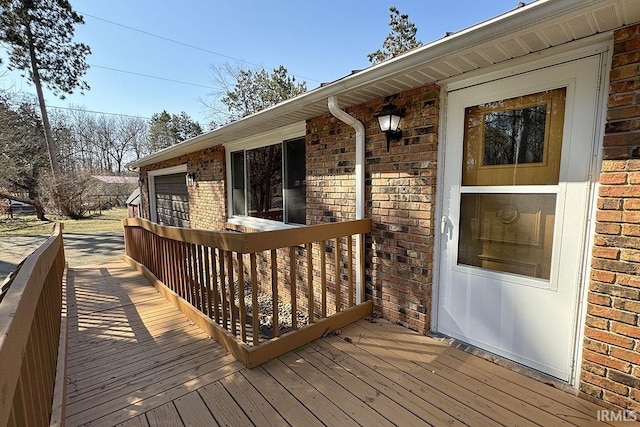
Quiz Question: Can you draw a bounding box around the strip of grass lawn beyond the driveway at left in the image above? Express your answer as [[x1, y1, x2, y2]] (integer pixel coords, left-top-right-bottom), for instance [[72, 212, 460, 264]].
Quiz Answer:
[[0, 208, 127, 237]]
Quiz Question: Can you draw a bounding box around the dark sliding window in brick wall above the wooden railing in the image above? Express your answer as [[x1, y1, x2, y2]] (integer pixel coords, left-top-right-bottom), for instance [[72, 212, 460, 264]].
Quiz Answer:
[[230, 138, 307, 224]]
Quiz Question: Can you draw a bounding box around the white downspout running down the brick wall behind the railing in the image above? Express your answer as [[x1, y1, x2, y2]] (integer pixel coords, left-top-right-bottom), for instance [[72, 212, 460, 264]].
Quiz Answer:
[[328, 95, 364, 304]]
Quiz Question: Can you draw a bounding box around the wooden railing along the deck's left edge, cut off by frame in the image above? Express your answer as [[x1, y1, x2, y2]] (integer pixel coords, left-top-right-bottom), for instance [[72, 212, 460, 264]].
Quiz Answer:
[[0, 224, 66, 426]]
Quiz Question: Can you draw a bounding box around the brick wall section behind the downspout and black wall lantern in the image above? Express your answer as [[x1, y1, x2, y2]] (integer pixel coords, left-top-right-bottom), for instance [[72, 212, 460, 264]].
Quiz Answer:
[[307, 85, 440, 332]]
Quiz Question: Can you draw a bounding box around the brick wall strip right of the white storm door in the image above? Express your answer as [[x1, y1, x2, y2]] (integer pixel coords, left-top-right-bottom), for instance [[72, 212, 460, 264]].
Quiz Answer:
[[580, 25, 640, 411]]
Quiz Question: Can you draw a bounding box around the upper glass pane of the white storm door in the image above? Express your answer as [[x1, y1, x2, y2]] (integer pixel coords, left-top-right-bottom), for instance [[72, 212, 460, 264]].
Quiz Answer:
[[462, 88, 566, 186]]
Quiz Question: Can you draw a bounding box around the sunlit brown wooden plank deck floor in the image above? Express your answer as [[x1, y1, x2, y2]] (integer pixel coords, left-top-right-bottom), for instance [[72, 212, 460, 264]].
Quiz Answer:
[[66, 263, 616, 427]]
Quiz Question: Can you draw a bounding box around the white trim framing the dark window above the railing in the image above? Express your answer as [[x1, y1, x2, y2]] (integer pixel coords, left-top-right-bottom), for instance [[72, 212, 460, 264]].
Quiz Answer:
[[224, 122, 307, 231]]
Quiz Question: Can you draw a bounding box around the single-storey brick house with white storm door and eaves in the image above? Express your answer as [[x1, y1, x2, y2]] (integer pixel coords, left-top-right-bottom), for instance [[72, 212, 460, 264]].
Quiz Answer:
[[132, 0, 640, 410]]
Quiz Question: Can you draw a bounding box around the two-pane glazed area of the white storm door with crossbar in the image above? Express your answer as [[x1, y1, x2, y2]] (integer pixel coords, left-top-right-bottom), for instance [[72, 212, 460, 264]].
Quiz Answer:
[[458, 88, 566, 280]]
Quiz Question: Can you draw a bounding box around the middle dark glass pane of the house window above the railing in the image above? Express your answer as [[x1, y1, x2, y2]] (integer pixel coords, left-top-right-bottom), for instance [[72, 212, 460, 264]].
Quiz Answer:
[[246, 144, 283, 221]]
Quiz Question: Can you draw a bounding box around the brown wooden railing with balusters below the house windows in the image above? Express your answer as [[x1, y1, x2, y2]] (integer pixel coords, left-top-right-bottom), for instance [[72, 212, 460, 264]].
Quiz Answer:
[[123, 218, 372, 367]]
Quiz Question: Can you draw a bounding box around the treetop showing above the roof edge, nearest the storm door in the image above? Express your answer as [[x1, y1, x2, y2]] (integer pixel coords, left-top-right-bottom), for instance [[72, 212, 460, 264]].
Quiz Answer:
[[367, 6, 422, 64]]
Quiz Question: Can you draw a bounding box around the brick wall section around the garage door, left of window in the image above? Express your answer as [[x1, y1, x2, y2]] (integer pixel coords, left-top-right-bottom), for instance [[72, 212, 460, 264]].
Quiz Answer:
[[140, 147, 226, 230]]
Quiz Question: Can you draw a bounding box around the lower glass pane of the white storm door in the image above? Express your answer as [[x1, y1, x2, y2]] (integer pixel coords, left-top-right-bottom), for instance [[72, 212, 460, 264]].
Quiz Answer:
[[458, 193, 556, 280]]
